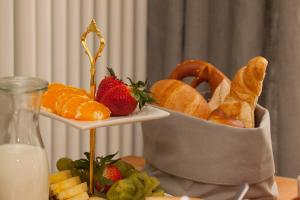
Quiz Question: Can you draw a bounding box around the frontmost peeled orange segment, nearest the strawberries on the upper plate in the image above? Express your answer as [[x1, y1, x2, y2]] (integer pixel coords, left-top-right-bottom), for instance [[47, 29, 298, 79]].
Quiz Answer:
[[75, 101, 110, 121]]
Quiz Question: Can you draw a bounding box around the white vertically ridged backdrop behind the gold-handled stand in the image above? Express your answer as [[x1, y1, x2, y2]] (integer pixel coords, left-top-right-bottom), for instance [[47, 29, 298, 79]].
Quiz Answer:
[[0, 0, 147, 170]]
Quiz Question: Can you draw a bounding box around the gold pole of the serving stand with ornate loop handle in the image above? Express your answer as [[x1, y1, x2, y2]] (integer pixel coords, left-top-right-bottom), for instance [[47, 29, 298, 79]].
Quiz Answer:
[[81, 19, 105, 194]]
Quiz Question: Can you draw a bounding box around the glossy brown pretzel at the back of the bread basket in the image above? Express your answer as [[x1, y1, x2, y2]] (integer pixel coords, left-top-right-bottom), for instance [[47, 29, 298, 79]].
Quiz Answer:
[[169, 60, 230, 93]]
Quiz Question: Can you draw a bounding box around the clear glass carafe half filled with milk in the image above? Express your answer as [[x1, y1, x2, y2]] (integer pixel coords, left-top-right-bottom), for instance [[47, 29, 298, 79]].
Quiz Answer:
[[0, 77, 49, 200]]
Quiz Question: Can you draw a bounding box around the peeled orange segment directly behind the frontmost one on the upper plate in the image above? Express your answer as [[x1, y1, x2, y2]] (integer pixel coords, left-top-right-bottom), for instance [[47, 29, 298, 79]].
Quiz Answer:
[[61, 95, 90, 119]]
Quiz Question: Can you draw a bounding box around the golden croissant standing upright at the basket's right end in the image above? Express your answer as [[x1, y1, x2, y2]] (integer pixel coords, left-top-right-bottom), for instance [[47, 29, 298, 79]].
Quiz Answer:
[[209, 56, 268, 128]]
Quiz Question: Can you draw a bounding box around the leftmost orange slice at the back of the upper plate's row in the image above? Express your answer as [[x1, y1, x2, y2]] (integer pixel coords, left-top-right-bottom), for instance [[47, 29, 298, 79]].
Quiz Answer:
[[41, 87, 87, 112]]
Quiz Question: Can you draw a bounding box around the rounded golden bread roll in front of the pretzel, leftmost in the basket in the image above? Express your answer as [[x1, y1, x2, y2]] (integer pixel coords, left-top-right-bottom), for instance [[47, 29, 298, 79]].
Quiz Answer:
[[150, 79, 211, 119]]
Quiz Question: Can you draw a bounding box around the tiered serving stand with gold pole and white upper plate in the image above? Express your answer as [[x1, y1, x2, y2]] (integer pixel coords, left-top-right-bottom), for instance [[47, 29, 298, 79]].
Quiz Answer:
[[41, 19, 169, 194]]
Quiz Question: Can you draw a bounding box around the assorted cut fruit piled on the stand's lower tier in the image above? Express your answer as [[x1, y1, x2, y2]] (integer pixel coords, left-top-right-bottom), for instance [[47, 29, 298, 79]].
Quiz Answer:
[[49, 152, 165, 200]]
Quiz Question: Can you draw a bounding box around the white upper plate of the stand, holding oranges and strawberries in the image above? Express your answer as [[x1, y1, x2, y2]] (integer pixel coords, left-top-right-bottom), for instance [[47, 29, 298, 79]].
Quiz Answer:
[[41, 105, 170, 130]]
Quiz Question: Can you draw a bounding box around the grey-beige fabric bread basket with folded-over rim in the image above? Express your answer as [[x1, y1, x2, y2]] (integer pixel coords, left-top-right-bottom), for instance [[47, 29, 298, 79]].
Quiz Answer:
[[142, 106, 278, 200]]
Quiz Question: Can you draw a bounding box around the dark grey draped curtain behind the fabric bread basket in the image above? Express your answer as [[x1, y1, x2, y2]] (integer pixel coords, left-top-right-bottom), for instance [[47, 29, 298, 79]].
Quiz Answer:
[[147, 0, 300, 177]]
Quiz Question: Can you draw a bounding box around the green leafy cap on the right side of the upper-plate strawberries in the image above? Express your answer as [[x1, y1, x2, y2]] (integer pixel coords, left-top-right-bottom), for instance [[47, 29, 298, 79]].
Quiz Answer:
[[127, 77, 154, 109]]
